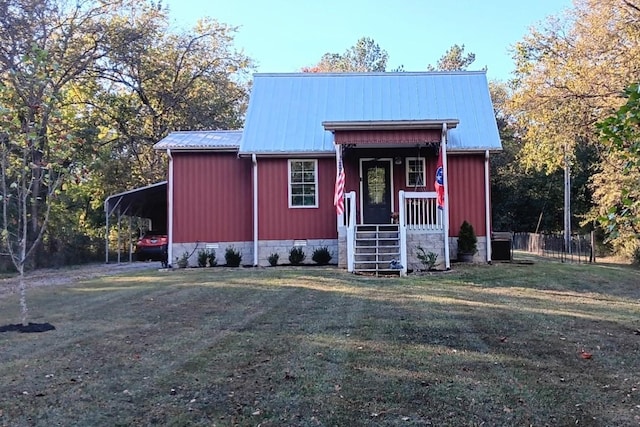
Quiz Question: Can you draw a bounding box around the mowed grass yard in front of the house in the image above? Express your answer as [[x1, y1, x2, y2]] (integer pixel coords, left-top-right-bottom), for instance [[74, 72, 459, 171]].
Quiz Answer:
[[0, 259, 640, 427]]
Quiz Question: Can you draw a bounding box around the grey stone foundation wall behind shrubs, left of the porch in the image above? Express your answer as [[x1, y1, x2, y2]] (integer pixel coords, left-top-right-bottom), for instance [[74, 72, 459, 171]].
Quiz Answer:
[[169, 239, 346, 267]]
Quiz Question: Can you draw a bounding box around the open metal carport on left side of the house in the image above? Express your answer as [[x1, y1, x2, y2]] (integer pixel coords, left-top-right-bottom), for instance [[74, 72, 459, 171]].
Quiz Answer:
[[104, 181, 167, 264]]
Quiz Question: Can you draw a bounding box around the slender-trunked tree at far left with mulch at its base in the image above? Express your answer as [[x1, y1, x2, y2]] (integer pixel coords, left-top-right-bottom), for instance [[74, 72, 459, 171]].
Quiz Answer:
[[0, 0, 129, 324]]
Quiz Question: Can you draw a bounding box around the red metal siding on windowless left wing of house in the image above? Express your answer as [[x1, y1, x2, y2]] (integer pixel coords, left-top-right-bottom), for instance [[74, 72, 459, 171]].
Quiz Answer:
[[173, 152, 253, 243]]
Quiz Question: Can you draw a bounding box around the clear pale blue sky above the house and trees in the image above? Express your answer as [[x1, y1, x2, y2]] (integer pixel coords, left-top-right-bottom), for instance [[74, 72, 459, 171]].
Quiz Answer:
[[162, 0, 572, 81]]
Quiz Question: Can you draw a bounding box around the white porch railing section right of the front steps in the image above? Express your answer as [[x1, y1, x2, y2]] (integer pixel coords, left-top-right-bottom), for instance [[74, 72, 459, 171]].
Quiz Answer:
[[398, 191, 444, 232]]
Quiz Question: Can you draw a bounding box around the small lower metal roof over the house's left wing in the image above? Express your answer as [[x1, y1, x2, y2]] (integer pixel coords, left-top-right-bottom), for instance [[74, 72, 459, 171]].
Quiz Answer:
[[153, 130, 242, 151]]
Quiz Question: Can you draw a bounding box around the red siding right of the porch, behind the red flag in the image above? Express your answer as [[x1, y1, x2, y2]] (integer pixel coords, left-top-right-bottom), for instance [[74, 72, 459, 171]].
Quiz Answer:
[[447, 153, 486, 236]]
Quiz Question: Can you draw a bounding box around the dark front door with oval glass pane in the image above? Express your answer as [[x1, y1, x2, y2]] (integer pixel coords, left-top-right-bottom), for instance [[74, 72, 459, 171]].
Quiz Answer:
[[362, 160, 392, 224]]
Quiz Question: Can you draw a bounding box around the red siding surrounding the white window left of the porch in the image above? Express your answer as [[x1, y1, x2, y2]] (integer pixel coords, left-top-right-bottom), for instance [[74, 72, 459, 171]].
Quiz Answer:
[[258, 157, 338, 240]]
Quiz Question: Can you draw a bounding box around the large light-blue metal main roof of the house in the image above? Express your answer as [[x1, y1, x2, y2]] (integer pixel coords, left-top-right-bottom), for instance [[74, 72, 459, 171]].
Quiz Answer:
[[240, 71, 502, 154]]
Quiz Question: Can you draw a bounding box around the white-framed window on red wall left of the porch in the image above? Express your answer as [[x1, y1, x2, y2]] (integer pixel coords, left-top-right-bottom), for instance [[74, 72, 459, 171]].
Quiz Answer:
[[289, 159, 318, 208]]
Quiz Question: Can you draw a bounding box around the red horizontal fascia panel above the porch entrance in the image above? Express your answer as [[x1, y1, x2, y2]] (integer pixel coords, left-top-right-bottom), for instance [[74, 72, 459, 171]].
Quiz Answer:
[[334, 129, 442, 144]]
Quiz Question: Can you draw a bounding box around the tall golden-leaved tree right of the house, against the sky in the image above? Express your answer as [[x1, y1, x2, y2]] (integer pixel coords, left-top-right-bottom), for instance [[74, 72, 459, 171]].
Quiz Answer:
[[507, 0, 640, 251]]
